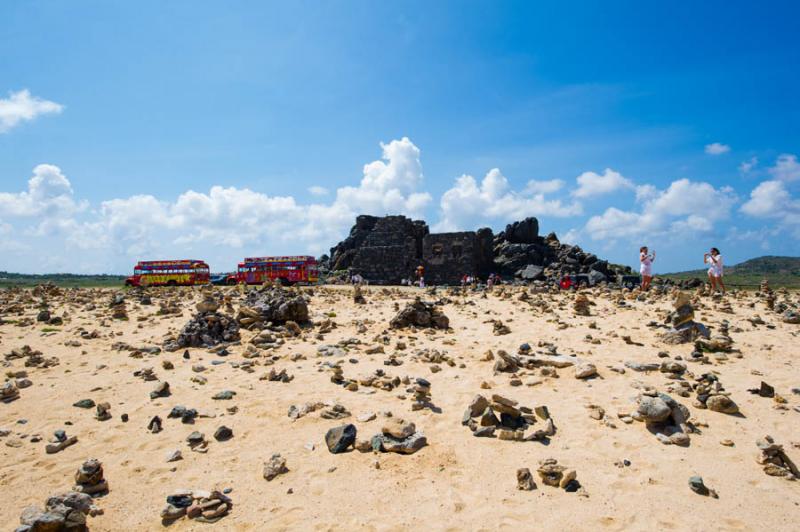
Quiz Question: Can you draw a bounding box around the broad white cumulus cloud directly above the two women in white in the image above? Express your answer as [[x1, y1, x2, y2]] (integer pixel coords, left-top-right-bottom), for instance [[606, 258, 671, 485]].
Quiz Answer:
[[584, 179, 736, 240]]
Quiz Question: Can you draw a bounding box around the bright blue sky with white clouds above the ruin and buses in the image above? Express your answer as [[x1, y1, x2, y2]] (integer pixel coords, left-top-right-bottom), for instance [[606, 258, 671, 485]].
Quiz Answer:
[[0, 1, 800, 272]]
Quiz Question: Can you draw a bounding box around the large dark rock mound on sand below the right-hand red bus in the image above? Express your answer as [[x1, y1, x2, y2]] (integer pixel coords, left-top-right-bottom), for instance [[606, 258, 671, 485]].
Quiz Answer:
[[236, 287, 308, 329]]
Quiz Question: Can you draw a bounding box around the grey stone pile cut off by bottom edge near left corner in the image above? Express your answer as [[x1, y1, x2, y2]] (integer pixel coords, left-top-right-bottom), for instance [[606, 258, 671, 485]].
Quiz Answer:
[[15, 491, 96, 532]]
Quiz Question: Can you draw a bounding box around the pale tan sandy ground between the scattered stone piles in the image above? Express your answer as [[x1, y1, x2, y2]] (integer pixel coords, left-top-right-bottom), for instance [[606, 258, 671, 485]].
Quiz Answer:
[[0, 287, 800, 530]]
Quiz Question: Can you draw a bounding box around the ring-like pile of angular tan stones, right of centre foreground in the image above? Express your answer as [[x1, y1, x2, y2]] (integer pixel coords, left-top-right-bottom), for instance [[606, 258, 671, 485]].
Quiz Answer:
[[461, 394, 556, 442]]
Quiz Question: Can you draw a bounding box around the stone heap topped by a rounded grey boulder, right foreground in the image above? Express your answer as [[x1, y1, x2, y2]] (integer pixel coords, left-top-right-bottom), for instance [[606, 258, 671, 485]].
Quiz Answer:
[[630, 390, 691, 447]]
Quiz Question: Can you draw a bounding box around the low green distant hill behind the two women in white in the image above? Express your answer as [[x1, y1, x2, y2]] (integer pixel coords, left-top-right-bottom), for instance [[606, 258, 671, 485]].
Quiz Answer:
[[658, 255, 800, 288]]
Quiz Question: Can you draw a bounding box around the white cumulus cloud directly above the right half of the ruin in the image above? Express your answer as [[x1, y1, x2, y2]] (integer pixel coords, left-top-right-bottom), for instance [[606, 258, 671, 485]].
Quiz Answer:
[[434, 168, 582, 231]]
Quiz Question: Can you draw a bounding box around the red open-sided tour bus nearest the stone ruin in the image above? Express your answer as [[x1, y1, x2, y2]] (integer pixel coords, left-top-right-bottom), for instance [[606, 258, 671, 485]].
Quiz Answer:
[[227, 255, 319, 285]]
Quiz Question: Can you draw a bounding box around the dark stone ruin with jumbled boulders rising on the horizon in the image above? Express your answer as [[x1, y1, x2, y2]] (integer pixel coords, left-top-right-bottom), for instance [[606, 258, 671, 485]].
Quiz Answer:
[[321, 215, 631, 285]]
